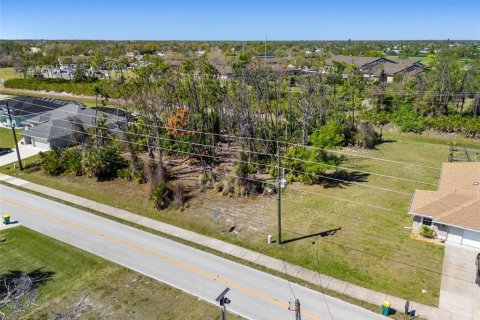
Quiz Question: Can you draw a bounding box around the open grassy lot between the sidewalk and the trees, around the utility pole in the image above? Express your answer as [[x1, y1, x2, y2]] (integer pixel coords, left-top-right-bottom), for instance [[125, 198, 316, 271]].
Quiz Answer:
[[0, 131, 480, 305]]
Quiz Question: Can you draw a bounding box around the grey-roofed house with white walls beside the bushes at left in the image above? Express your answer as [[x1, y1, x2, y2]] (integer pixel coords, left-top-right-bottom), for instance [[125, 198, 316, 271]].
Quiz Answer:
[[22, 103, 126, 150]]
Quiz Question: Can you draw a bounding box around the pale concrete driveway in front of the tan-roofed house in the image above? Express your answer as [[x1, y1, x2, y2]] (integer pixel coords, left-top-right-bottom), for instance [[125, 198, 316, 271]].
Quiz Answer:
[[439, 243, 480, 320]]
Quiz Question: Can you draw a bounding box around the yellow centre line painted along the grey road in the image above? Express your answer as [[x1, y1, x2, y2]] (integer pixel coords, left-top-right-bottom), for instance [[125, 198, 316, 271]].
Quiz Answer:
[[0, 197, 323, 320]]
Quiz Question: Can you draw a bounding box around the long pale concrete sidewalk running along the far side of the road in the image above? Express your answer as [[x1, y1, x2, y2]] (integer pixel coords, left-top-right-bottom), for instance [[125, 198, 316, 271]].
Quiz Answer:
[[0, 174, 454, 320]]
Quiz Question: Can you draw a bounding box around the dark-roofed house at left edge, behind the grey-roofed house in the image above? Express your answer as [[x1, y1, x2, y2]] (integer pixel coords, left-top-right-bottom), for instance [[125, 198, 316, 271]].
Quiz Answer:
[[0, 97, 75, 128]]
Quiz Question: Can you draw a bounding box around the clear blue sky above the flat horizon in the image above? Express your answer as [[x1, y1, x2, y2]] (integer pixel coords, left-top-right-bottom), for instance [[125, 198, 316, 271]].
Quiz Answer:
[[0, 0, 480, 40]]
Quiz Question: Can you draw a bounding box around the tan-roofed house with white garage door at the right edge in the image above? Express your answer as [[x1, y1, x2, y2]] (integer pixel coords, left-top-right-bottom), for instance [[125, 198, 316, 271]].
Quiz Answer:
[[409, 162, 480, 248]]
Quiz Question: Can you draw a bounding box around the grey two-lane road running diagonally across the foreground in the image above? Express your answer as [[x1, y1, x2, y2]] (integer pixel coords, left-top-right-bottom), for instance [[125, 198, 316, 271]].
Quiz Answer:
[[0, 185, 386, 320]]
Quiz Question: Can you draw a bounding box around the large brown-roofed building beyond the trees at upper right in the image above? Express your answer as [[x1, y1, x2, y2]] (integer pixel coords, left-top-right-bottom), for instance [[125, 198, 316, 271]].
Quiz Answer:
[[324, 55, 426, 82]]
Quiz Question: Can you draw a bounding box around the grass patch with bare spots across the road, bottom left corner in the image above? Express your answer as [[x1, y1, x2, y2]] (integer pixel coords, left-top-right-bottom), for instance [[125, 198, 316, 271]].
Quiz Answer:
[[0, 227, 239, 319]]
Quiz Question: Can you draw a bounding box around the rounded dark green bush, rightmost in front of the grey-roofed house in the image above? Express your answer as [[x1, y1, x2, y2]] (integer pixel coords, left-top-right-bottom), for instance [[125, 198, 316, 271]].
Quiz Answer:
[[82, 147, 126, 180]]
